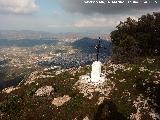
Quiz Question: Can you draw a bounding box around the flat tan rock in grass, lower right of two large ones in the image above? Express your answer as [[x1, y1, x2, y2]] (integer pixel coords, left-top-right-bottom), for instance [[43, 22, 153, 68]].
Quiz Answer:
[[52, 95, 71, 107]]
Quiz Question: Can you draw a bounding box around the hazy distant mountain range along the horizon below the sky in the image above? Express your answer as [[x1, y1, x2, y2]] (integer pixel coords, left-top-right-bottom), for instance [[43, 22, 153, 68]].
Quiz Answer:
[[0, 30, 110, 41]]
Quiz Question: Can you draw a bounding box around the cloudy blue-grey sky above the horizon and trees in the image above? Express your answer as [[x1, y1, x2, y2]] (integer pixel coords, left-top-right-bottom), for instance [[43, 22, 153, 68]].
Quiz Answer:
[[0, 0, 160, 33]]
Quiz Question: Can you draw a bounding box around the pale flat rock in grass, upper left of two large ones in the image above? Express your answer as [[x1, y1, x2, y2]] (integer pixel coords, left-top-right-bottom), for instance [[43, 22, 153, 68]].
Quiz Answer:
[[35, 86, 54, 96]]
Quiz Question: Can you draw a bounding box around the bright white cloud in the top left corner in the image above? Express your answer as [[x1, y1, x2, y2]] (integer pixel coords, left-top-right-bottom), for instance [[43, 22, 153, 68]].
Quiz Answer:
[[0, 0, 38, 14]]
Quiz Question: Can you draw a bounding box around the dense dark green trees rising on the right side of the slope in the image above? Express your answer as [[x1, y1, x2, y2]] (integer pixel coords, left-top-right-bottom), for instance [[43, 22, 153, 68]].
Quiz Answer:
[[111, 12, 160, 62]]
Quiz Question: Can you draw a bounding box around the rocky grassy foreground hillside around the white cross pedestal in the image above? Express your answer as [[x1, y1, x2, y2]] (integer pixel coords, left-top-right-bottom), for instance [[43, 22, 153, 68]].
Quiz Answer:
[[0, 57, 160, 120]]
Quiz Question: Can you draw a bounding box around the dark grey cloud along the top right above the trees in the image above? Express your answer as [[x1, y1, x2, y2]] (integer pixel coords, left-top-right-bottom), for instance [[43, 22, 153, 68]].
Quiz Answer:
[[59, 0, 160, 14]]
